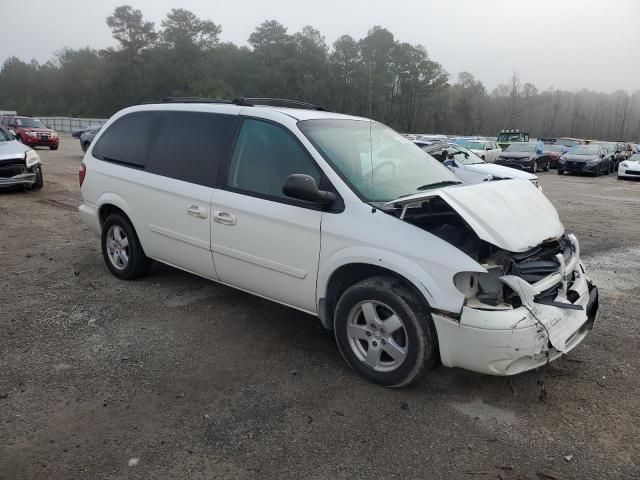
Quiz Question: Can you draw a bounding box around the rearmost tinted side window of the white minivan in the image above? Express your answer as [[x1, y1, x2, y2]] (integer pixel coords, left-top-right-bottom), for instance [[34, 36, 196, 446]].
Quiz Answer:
[[93, 111, 160, 167]]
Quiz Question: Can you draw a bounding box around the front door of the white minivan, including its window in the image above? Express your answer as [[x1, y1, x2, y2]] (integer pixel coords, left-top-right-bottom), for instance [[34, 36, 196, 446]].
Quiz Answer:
[[211, 118, 322, 313]]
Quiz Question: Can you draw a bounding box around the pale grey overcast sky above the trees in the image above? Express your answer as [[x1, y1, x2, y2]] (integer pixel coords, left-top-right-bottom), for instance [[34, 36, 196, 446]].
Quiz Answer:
[[0, 0, 640, 92]]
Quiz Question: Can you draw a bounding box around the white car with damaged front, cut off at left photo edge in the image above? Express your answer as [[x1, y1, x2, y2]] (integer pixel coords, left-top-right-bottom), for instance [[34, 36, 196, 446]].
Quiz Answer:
[[0, 126, 43, 190]]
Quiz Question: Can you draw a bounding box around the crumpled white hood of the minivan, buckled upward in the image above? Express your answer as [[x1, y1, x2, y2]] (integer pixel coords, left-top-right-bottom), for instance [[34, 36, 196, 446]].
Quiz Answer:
[[387, 179, 564, 252]]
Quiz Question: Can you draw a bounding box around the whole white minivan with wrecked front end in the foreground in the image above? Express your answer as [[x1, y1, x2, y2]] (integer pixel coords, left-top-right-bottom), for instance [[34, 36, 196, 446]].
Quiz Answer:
[[79, 99, 598, 387]]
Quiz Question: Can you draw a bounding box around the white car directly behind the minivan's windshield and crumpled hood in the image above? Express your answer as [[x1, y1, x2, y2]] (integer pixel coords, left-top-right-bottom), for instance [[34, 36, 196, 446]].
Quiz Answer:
[[418, 143, 538, 186]]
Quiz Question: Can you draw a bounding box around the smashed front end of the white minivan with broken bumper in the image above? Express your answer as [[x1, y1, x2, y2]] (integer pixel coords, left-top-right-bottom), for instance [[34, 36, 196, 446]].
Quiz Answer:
[[389, 182, 598, 375]]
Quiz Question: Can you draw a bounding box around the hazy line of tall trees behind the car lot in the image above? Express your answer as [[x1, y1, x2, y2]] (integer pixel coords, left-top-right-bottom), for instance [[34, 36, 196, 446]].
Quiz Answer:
[[0, 5, 640, 140]]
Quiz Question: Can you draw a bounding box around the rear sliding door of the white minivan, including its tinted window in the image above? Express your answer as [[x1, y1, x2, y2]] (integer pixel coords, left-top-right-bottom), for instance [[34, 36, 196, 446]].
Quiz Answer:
[[140, 111, 238, 280]]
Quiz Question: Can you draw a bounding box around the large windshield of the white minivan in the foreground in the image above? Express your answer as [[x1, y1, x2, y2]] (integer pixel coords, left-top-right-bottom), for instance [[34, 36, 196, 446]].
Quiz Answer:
[[298, 119, 461, 202]]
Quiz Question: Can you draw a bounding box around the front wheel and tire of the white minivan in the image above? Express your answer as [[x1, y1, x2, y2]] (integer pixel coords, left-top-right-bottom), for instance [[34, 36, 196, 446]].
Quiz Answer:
[[334, 276, 439, 387]]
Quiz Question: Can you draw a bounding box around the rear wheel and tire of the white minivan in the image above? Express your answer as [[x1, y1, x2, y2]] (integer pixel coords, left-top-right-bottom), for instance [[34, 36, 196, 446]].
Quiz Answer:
[[100, 213, 151, 280]]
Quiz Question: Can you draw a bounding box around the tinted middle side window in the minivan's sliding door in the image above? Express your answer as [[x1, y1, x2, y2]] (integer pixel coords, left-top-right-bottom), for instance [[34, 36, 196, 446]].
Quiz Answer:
[[146, 111, 239, 187]]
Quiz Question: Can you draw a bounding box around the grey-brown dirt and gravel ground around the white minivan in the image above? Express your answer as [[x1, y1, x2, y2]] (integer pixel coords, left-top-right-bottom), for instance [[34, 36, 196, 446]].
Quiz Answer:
[[0, 138, 640, 480]]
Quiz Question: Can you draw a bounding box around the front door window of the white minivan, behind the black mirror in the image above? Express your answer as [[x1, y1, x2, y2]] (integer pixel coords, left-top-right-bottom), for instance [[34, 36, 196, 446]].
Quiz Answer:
[[227, 119, 321, 199]]
